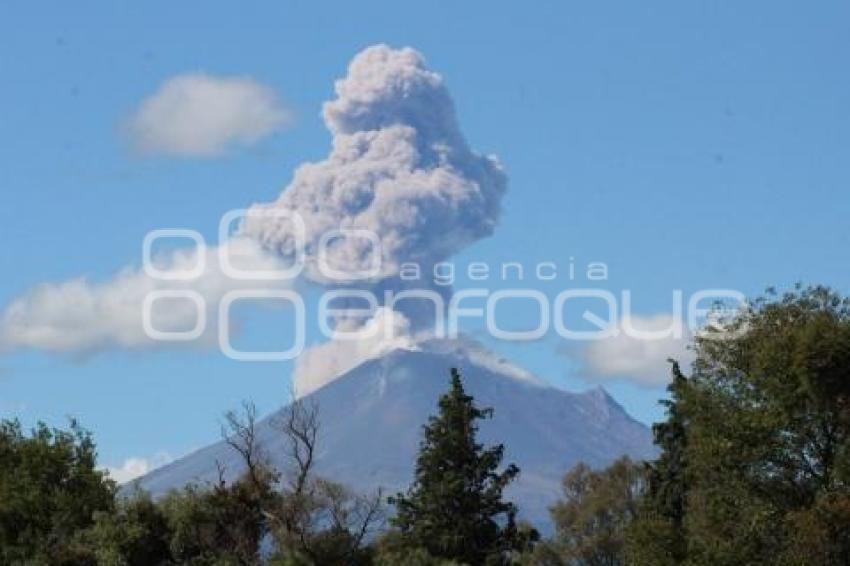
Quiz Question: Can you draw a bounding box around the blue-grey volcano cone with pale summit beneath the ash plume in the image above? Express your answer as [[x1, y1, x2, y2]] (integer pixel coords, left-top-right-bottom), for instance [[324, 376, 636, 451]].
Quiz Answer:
[[132, 341, 653, 530]]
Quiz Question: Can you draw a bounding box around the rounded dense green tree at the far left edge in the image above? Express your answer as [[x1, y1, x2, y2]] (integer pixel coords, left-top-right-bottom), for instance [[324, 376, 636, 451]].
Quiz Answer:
[[0, 421, 114, 564]]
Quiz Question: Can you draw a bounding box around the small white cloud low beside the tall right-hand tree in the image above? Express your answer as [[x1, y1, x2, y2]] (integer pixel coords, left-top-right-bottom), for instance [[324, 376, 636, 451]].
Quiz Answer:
[[579, 315, 694, 386]]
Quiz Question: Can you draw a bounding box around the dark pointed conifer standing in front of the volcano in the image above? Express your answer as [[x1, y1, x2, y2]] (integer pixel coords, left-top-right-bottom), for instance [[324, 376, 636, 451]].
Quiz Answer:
[[389, 369, 536, 566]]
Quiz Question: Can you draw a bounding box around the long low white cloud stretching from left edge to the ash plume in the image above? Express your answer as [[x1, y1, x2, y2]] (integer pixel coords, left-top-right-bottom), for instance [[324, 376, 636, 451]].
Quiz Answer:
[[0, 238, 288, 354]]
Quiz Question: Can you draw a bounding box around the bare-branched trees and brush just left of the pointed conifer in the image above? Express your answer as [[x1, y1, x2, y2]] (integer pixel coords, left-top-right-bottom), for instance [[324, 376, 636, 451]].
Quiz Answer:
[[169, 399, 383, 566]]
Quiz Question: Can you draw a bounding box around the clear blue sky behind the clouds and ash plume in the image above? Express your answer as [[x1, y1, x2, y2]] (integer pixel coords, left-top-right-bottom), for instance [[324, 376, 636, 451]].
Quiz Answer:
[[0, 2, 850, 480]]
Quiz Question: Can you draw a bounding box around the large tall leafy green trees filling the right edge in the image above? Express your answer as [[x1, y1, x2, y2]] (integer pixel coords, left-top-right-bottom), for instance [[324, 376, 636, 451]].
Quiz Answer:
[[629, 287, 850, 565]]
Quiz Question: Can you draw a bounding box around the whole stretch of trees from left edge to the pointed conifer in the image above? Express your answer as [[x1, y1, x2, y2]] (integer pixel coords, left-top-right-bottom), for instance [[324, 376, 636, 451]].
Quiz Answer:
[[0, 402, 382, 566]]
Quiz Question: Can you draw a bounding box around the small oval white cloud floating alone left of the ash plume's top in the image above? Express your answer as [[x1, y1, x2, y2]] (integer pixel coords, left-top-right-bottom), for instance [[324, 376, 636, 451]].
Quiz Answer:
[[128, 73, 290, 157]]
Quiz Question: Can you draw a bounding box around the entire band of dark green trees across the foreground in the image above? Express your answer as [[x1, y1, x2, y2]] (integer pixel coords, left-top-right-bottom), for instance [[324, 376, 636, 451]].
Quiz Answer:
[[0, 288, 850, 566]]
